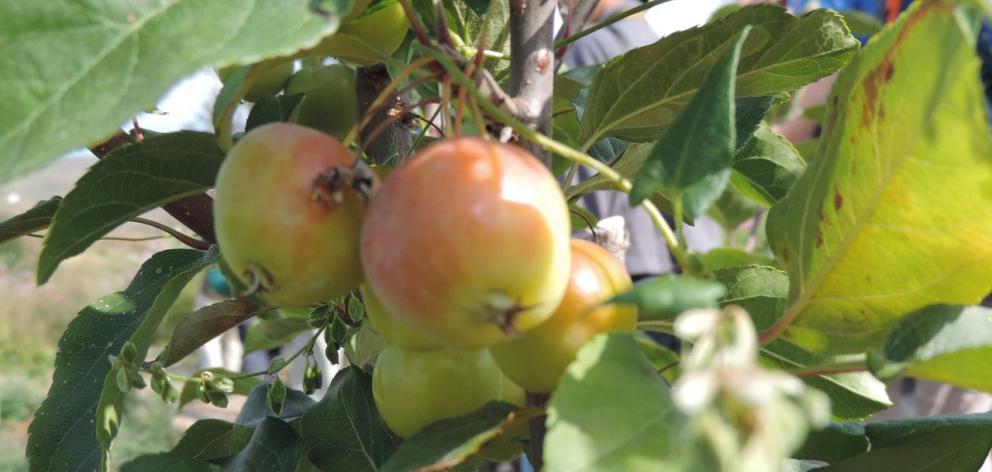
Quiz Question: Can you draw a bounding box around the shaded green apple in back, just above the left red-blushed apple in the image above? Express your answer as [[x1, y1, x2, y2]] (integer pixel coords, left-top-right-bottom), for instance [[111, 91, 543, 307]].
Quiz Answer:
[[286, 64, 358, 138]]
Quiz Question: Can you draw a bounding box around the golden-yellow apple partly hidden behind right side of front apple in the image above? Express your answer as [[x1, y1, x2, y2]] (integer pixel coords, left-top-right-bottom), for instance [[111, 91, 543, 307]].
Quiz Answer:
[[490, 239, 637, 393]]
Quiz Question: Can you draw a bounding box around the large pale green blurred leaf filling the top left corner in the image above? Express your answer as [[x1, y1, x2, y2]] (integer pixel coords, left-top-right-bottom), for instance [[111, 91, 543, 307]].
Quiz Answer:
[[0, 0, 338, 181]]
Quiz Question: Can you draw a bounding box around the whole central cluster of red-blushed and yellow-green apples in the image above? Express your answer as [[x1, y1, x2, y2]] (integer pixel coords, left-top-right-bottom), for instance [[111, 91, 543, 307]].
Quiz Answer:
[[215, 127, 637, 460]]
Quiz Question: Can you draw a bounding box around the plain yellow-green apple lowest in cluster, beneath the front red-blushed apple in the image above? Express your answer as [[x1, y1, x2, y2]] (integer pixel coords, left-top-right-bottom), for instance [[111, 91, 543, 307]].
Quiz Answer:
[[372, 346, 503, 438]]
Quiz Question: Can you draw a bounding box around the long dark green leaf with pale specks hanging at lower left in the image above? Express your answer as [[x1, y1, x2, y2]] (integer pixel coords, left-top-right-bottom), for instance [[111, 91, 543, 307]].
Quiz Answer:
[[27, 249, 217, 470]]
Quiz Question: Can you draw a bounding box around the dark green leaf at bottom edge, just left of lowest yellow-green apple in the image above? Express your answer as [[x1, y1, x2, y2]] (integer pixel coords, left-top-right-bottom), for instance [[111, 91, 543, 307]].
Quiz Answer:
[[300, 367, 393, 472]]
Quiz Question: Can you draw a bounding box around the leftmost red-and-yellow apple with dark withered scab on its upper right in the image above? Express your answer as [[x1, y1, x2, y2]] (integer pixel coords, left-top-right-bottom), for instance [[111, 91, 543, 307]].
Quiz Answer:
[[214, 123, 377, 307]]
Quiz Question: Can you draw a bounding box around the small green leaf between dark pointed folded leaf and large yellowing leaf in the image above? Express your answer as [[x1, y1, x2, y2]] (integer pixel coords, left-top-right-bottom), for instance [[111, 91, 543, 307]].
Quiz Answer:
[[730, 125, 806, 207]]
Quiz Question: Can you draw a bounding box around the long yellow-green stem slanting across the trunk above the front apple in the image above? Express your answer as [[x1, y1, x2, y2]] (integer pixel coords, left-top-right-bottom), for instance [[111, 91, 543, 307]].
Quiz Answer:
[[424, 49, 690, 270]]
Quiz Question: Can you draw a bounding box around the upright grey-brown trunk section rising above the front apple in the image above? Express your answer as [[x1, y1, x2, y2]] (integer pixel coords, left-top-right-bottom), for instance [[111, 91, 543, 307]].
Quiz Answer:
[[509, 0, 555, 167]]
